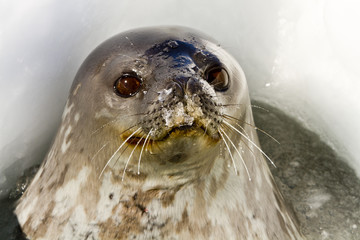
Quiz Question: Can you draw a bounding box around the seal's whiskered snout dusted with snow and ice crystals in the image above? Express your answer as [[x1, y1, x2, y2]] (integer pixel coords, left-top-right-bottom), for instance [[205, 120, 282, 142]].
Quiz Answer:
[[140, 77, 222, 141]]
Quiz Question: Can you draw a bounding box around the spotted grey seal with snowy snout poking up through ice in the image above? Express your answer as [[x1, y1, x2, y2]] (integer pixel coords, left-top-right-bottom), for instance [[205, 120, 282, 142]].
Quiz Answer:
[[15, 27, 303, 240]]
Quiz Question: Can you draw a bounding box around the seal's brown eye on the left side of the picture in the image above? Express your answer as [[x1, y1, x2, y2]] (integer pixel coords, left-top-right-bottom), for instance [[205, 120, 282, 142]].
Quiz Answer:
[[114, 75, 142, 98]]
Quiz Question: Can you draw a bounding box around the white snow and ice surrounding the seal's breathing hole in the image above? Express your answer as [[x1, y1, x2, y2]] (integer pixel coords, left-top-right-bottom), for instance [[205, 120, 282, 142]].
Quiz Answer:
[[0, 0, 360, 196]]
